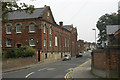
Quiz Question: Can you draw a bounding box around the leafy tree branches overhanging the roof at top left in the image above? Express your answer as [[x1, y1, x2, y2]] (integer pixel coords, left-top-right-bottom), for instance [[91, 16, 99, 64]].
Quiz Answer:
[[1, 0, 35, 21]]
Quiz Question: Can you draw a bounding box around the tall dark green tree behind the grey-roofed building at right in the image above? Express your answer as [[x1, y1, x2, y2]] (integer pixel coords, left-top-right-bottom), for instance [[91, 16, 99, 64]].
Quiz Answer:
[[96, 13, 118, 45]]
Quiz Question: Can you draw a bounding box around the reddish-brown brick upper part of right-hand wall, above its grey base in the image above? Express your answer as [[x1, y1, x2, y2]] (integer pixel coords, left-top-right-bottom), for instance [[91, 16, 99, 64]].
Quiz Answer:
[[92, 46, 120, 69]]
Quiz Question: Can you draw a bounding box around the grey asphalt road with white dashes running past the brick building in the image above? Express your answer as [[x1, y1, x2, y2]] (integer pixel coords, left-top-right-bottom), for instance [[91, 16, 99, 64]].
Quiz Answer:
[[2, 53, 91, 78]]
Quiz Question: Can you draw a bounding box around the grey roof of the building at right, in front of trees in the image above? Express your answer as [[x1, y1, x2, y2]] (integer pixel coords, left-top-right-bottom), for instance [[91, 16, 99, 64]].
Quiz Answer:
[[106, 25, 120, 35]]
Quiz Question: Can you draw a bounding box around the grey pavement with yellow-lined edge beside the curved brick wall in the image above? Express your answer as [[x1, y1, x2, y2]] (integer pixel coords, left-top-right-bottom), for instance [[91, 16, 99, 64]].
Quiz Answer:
[[65, 59, 99, 80]]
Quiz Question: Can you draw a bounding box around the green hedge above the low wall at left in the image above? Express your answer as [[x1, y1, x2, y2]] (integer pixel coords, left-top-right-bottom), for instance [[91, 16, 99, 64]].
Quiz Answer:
[[3, 46, 35, 58]]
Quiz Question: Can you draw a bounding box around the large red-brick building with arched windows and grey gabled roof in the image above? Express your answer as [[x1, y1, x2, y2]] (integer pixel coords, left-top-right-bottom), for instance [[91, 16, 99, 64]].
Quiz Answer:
[[2, 6, 77, 61]]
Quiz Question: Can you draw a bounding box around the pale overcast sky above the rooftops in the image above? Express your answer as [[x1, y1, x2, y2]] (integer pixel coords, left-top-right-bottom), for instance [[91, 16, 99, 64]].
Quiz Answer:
[[18, 0, 120, 42]]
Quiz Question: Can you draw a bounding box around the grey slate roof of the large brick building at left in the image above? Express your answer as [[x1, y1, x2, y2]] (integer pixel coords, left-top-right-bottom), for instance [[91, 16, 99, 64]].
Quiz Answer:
[[8, 7, 45, 20]]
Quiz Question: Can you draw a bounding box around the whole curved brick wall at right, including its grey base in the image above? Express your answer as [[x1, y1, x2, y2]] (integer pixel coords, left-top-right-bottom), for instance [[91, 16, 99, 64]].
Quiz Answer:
[[91, 46, 120, 78]]
